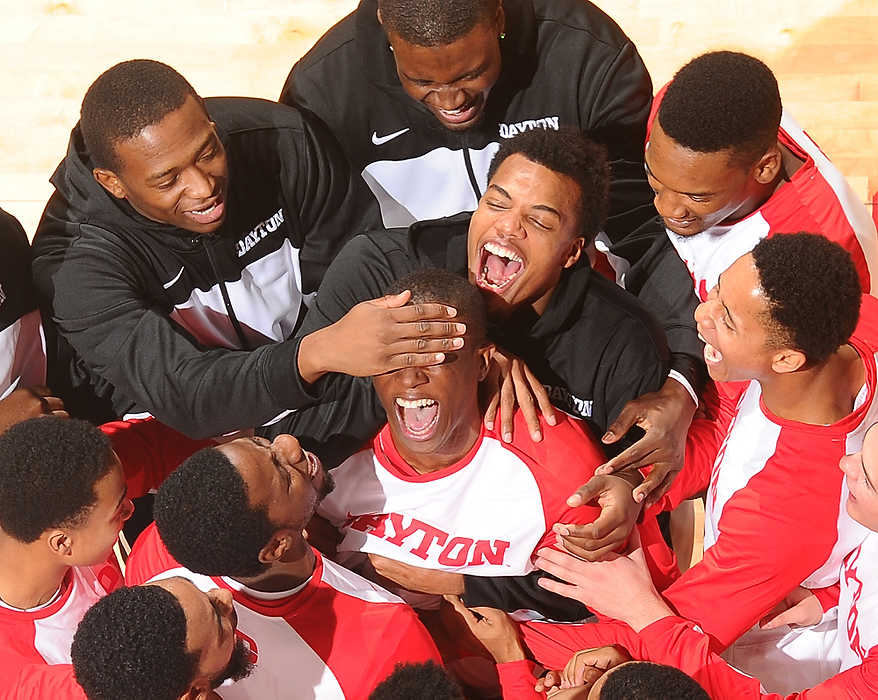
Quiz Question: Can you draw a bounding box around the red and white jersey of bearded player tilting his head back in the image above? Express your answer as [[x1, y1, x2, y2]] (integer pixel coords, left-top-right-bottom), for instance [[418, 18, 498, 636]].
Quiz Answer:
[[125, 523, 441, 700]]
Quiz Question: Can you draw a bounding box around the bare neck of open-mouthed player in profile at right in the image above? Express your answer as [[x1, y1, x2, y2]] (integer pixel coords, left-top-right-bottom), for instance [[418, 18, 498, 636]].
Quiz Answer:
[[760, 345, 866, 425]]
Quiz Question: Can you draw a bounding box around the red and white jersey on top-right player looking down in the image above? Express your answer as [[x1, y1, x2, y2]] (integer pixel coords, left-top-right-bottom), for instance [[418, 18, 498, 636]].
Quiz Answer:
[[647, 90, 878, 301]]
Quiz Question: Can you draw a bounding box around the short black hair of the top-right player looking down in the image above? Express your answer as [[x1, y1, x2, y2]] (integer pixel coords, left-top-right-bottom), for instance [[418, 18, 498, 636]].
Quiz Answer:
[[658, 51, 782, 166]]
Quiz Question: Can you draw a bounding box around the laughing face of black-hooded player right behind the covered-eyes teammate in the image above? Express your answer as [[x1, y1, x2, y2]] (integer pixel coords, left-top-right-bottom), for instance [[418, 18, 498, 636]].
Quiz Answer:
[[467, 153, 584, 314]]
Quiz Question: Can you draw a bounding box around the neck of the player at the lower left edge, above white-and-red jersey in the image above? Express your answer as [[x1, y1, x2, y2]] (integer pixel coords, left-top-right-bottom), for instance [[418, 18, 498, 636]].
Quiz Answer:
[[0, 533, 70, 610]]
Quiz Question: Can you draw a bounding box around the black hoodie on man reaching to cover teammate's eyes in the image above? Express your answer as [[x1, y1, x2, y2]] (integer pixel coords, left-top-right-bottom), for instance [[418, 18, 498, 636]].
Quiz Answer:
[[33, 98, 372, 437]]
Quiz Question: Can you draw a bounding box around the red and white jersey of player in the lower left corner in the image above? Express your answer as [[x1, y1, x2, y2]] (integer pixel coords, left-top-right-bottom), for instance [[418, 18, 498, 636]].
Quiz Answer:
[[0, 562, 122, 700]]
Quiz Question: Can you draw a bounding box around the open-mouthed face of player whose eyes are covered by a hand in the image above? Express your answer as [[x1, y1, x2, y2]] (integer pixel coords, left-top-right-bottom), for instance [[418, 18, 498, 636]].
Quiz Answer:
[[372, 332, 492, 472]]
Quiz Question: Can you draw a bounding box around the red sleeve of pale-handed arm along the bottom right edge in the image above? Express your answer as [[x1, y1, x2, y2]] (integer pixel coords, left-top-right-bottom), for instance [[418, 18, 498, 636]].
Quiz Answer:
[[640, 616, 878, 700]]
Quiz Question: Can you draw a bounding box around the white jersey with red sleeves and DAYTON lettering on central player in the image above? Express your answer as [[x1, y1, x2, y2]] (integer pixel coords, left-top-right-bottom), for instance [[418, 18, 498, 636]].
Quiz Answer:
[[318, 414, 604, 588]]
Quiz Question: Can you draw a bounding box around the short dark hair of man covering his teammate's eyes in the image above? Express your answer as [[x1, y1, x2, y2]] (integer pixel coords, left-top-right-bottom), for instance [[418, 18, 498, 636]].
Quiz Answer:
[[79, 59, 201, 170]]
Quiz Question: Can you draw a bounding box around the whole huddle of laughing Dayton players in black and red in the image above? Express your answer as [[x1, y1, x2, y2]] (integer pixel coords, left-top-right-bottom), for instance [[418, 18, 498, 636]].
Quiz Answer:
[[0, 0, 878, 700]]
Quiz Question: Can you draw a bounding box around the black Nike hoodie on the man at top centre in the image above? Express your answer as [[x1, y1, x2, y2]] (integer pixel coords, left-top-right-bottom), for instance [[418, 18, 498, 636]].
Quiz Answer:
[[280, 0, 706, 391]]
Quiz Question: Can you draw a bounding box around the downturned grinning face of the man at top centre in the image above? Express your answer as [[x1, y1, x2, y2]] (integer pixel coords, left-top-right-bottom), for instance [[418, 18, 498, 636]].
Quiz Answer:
[[388, 7, 504, 131]]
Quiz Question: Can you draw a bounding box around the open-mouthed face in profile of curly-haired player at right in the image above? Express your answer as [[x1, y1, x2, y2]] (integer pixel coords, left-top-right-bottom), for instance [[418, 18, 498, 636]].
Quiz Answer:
[[695, 253, 778, 382]]
